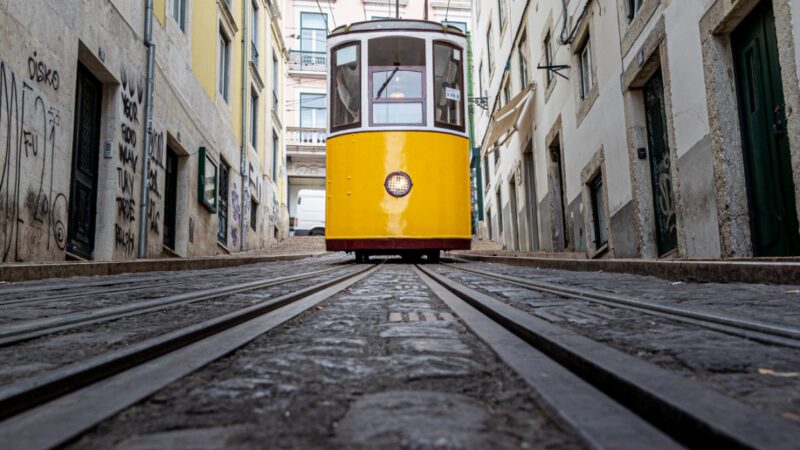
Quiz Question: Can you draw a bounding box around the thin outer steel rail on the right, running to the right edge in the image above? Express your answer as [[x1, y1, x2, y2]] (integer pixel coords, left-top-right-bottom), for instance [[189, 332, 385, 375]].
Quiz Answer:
[[442, 264, 800, 348]]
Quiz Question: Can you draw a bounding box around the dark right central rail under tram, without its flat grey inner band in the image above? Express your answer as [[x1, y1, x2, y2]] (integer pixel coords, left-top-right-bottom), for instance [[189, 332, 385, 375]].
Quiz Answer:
[[418, 266, 800, 449]]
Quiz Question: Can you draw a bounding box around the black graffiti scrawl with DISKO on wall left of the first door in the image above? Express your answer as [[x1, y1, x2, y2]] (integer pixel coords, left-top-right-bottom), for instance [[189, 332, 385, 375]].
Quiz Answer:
[[0, 59, 68, 262]]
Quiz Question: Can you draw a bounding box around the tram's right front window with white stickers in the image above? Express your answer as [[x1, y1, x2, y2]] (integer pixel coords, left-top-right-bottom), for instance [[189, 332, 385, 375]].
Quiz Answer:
[[433, 42, 464, 131]]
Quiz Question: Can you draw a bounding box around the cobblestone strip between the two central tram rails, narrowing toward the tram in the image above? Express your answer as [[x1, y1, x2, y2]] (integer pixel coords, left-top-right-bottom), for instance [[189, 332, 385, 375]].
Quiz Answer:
[[72, 265, 580, 449]]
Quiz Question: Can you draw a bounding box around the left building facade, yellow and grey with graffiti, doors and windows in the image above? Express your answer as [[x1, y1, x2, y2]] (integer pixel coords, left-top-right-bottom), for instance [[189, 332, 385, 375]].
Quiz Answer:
[[0, 0, 288, 262]]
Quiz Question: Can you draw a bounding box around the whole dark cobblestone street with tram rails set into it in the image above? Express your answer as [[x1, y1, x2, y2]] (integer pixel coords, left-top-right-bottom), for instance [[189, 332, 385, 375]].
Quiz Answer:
[[0, 254, 800, 449]]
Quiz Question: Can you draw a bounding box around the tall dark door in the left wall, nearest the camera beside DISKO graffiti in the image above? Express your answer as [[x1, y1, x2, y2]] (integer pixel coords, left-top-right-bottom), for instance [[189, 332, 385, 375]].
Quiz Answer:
[[67, 64, 103, 259]]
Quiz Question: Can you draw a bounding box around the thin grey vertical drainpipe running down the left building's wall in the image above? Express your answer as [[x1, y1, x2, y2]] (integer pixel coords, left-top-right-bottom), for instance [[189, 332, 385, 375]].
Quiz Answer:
[[138, 0, 156, 258]]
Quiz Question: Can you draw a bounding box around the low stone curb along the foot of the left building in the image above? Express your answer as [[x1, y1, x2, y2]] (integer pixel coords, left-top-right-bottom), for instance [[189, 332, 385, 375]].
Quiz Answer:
[[0, 252, 324, 283]]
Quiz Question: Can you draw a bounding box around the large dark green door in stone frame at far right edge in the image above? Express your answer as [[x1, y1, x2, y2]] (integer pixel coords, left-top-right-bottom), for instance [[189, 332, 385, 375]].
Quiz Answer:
[[731, 1, 800, 256]]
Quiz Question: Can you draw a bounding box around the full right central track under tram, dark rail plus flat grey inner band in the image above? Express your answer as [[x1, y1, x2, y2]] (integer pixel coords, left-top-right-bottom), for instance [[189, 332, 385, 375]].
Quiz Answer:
[[417, 266, 800, 449]]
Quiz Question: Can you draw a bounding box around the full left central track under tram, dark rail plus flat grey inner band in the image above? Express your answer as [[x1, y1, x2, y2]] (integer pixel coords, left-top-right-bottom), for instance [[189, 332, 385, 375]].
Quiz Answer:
[[0, 265, 379, 448]]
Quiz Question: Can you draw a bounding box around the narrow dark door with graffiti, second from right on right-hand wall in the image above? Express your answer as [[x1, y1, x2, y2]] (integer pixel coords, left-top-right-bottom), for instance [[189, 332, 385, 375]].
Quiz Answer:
[[644, 70, 678, 256]]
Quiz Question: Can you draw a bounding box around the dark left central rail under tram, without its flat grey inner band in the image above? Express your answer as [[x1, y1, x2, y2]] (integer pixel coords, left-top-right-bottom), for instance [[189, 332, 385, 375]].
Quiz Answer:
[[0, 264, 380, 428]]
